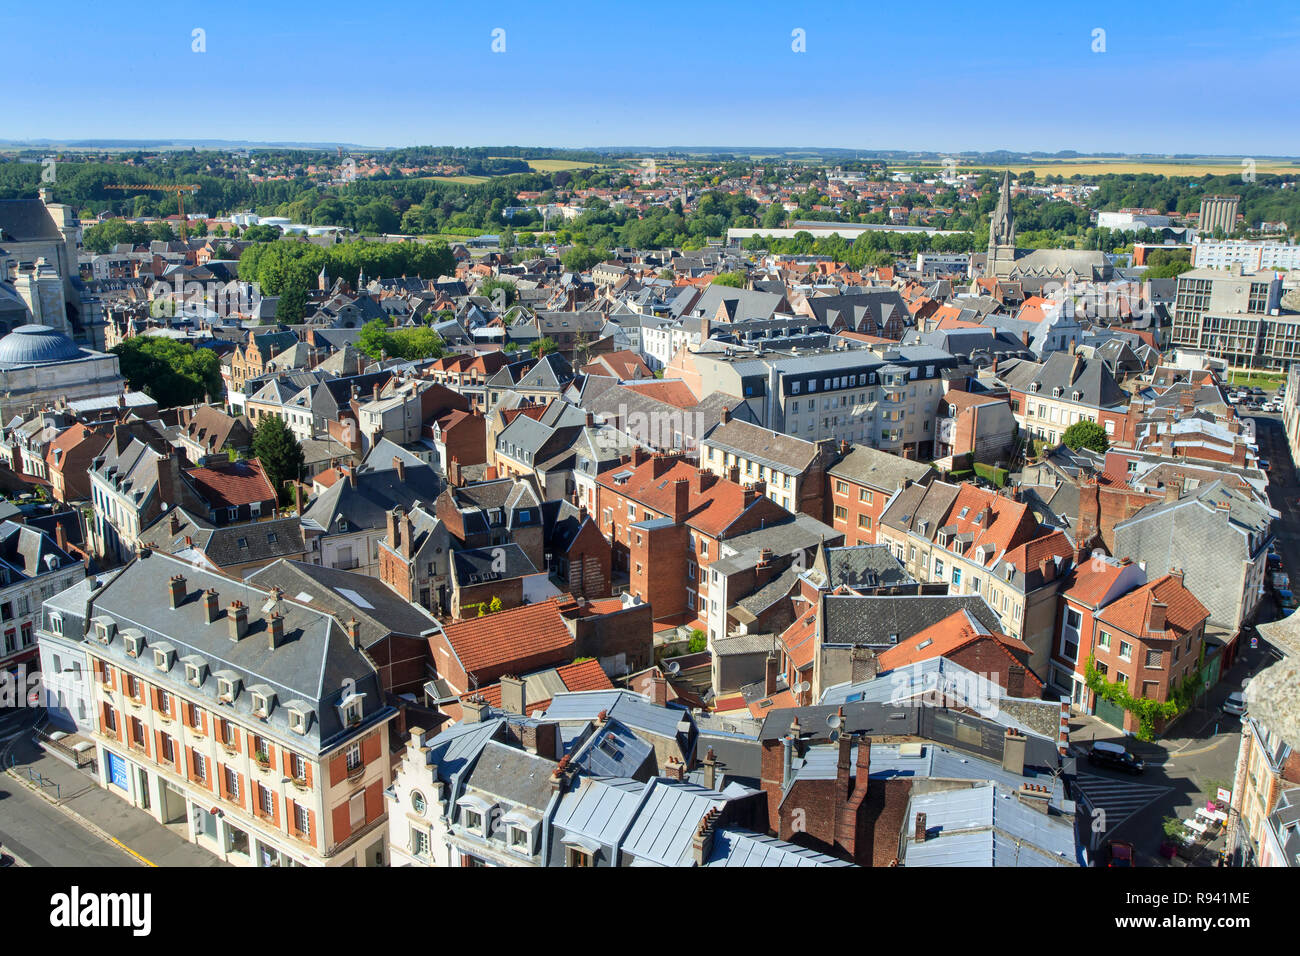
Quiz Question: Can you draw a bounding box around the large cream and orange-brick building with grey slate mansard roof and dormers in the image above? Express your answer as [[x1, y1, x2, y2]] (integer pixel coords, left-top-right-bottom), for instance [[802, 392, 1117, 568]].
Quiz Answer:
[[40, 550, 397, 866]]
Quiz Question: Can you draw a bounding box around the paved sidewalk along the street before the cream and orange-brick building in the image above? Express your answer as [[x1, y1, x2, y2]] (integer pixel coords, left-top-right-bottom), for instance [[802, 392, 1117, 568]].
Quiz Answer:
[[5, 735, 224, 866]]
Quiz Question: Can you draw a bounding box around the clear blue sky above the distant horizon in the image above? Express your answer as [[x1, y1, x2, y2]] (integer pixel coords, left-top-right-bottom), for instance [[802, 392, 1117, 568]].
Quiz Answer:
[[0, 0, 1300, 156]]
